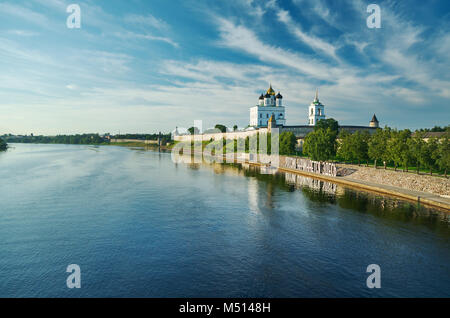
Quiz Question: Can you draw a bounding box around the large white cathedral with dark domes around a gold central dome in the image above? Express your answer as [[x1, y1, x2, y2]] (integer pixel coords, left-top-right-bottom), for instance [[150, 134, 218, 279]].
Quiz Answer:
[[250, 85, 286, 128]]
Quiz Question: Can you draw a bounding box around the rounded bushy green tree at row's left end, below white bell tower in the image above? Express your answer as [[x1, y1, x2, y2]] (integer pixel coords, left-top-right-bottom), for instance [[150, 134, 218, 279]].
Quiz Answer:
[[303, 128, 337, 161]]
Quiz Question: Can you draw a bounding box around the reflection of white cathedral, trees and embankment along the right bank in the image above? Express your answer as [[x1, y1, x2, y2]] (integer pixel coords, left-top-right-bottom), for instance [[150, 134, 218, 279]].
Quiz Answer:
[[178, 155, 450, 234]]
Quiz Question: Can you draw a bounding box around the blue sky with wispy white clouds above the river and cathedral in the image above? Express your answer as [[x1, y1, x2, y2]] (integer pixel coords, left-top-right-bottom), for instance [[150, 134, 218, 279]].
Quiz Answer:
[[0, 0, 450, 135]]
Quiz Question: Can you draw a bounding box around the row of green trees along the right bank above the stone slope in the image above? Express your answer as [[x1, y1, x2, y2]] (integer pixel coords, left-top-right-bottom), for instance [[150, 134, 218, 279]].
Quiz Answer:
[[303, 118, 450, 175]]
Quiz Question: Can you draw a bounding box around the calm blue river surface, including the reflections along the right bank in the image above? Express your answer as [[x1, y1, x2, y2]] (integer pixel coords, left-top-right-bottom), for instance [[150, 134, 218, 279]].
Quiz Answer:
[[0, 144, 450, 297]]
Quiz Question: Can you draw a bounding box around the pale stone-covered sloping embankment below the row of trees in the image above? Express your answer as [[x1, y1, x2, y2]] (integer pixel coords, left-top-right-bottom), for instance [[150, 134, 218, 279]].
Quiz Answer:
[[337, 165, 450, 196]]
